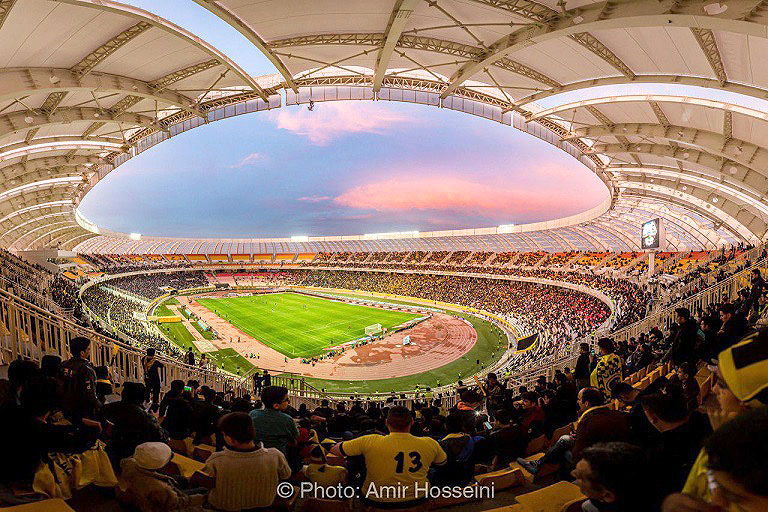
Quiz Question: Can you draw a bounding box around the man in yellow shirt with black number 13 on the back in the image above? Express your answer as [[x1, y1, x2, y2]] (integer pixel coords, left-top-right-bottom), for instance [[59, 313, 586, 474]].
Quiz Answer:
[[332, 406, 446, 509]]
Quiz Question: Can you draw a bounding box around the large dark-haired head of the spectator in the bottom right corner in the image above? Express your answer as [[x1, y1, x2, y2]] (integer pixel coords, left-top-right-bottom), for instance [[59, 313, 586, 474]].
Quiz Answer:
[[663, 407, 768, 512]]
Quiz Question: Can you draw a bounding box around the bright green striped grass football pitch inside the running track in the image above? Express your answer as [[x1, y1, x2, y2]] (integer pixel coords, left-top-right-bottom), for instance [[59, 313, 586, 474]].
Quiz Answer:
[[198, 293, 420, 358]]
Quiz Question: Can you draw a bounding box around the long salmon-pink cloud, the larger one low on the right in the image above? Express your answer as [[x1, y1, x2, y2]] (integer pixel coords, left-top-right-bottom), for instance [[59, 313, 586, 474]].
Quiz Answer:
[[334, 175, 594, 217]]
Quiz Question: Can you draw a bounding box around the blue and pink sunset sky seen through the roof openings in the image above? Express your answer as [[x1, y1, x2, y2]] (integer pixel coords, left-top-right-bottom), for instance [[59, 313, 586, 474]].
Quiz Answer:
[[80, 0, 766, 237]]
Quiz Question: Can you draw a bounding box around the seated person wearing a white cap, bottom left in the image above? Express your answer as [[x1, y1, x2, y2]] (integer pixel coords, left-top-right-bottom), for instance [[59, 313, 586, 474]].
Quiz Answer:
[[115, 440, 205, 512]]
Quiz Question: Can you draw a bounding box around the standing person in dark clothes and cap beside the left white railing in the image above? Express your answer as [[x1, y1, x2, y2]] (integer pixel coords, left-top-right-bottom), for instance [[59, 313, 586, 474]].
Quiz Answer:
[[61, 337, 101, 424]]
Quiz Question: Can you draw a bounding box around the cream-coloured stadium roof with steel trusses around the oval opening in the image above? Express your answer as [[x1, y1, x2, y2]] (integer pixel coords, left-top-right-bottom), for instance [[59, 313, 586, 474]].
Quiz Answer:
[[0, 0, 768, 252]]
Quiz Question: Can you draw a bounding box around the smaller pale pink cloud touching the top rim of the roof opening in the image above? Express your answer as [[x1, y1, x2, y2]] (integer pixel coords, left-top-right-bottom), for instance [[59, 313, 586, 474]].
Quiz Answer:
[[272, 101, 410, 146]]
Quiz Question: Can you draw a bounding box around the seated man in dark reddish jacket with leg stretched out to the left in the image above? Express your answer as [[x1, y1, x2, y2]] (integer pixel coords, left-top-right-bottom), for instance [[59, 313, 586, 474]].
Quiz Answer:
[[517, 388, 632, 475]]
